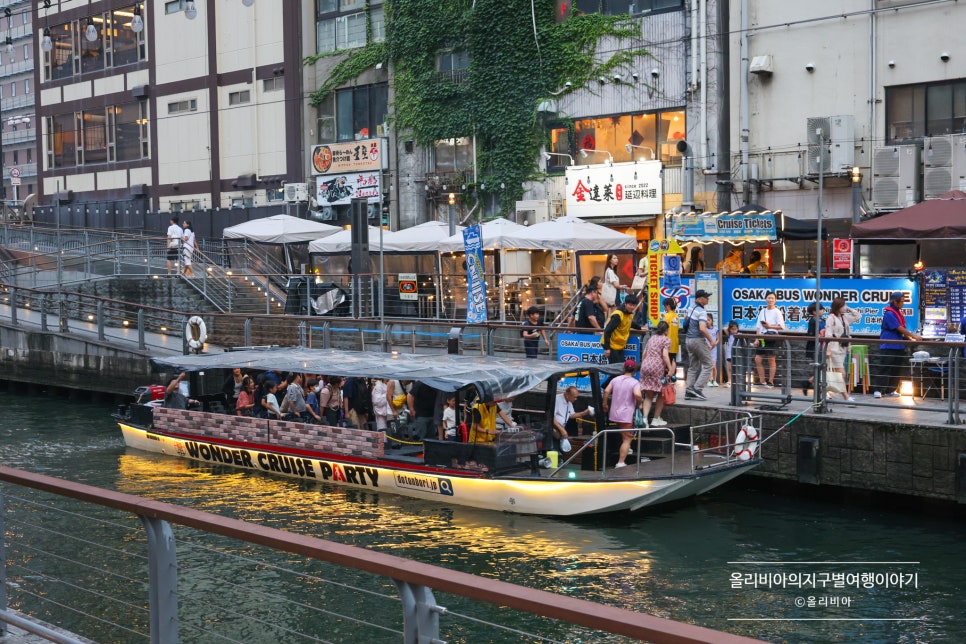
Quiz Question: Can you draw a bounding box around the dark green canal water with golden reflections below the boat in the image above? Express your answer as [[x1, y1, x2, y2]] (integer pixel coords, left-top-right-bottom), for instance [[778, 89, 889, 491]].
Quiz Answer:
[[0, 393, 966, 642]]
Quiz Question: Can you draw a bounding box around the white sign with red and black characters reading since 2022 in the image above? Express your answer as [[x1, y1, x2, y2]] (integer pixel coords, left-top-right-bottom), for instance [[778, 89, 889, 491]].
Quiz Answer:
[[566, 161, 664, 218]]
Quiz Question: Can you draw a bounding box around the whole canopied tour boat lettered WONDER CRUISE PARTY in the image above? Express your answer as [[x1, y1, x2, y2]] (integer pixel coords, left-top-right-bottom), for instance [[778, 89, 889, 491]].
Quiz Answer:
[[114, 348, 762, 516]]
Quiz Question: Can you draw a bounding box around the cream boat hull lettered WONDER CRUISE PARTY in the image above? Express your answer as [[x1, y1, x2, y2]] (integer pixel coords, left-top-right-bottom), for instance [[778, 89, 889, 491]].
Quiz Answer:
[[118, 420, 760, 516]]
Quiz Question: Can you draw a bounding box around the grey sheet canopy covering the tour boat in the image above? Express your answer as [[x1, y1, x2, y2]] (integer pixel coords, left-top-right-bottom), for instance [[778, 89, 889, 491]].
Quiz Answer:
[[152, 347, 623, 400]]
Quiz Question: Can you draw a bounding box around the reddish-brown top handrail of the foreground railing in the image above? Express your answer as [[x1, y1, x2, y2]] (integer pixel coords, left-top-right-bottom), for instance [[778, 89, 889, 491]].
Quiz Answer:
[[0, 466, 755, 644]]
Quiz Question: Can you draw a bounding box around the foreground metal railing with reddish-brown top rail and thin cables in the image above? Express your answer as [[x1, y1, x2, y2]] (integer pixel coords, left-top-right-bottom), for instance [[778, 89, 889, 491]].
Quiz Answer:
[[0, 466, 753, 644]]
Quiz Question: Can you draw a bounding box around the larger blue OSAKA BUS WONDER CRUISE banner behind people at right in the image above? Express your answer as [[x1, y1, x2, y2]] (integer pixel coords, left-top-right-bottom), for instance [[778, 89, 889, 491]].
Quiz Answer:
[[719, 277, 919, 336]]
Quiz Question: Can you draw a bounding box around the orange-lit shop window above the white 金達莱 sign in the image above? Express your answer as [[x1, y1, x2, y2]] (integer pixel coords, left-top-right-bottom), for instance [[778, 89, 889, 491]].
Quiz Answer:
[[550, 110, 687, 168]]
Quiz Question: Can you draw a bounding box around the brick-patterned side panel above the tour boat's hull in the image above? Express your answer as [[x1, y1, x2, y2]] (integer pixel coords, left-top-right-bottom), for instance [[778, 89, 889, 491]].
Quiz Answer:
[[154, 407, 386, 458]]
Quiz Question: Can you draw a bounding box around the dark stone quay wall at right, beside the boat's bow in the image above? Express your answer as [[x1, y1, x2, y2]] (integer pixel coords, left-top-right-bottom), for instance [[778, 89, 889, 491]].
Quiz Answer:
[[665, 405, 966, 502]]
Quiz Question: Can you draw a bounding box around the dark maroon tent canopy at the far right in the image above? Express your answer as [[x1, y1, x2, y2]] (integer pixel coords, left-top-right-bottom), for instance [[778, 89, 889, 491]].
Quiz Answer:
[[852, 190, 966, 241]]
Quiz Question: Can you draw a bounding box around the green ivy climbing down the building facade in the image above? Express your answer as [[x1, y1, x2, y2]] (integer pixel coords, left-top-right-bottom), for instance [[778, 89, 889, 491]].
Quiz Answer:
[[306, 0, 648, 216]]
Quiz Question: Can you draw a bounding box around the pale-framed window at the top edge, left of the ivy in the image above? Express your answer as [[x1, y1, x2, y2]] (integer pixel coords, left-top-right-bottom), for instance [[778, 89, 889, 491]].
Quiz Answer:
[[316, 0, 386, 54]]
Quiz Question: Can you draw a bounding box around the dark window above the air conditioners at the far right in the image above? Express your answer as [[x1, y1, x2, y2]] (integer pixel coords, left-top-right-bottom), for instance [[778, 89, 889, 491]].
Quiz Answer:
[[886, 79, 966, 144]]
